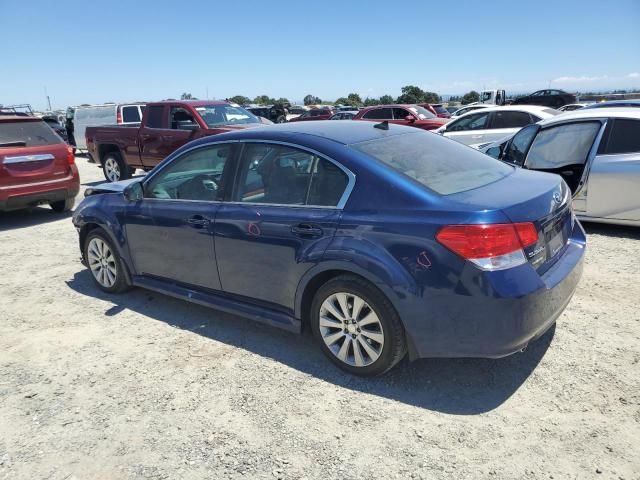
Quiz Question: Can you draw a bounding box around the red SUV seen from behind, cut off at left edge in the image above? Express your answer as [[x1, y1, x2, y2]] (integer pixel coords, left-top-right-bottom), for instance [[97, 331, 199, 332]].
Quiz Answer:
[[0, 115, 80, 212]]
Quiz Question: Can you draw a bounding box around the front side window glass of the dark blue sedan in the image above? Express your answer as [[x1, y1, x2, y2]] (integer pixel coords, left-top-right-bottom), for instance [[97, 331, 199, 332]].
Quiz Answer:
[[145, 145, 232, 201]]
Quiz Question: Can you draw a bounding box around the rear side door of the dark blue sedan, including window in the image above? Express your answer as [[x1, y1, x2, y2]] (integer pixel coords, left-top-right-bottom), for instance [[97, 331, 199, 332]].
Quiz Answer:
[[215, 143, 348, 310]]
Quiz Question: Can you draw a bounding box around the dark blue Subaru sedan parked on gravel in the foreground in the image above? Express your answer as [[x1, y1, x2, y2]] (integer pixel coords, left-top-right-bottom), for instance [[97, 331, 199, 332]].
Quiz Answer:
[[73, 121, 585, 375]]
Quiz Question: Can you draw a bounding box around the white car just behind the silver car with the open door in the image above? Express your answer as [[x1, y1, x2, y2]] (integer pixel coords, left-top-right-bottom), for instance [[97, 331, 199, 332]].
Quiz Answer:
[[435, 105, 560, 148]]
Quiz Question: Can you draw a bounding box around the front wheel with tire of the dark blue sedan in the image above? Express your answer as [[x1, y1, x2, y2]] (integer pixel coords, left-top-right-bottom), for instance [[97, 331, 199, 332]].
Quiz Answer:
[[84, 229, 129, 293]]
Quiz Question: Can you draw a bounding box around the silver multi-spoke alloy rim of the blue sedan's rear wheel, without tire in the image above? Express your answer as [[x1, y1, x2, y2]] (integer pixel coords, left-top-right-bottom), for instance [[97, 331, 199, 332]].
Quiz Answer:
[[319, 292, 384, 367]]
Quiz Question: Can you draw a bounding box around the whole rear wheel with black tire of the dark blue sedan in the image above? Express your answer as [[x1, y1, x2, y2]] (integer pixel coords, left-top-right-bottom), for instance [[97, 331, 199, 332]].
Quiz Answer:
[[310, 275, 407, 376]]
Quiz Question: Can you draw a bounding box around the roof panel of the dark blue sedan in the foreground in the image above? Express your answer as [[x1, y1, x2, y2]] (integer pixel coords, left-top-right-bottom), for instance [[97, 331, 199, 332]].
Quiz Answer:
[[189, 120, 418, 145]]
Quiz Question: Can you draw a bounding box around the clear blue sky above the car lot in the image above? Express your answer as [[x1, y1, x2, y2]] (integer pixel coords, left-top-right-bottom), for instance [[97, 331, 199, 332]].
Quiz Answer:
[[0, 0, 640, 108]]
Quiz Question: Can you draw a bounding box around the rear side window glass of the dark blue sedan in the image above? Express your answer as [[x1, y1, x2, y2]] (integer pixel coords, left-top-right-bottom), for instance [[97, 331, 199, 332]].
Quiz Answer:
[[234, 144, 348, 207]]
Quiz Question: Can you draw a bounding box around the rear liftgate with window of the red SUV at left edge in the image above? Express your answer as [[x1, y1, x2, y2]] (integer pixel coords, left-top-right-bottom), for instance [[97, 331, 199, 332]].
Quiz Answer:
[[0, 117, 71, 189]]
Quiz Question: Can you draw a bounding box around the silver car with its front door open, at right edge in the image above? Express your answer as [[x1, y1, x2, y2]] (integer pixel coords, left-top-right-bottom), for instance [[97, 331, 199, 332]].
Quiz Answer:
[[480, 108, 640, 226]]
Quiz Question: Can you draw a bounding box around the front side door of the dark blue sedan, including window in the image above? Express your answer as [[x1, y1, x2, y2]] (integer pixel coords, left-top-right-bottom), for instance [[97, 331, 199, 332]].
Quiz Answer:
[[125, 144, 234, 290]]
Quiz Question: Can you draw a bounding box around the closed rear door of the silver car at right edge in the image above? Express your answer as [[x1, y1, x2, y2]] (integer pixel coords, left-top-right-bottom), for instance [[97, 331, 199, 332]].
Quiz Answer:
[[586, 118, 640, 221]]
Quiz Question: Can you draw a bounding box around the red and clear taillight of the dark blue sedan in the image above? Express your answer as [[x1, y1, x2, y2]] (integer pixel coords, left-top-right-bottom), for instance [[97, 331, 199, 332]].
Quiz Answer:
[[436, 223, 538, 270]]
